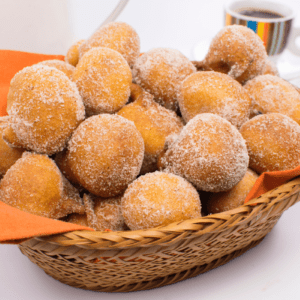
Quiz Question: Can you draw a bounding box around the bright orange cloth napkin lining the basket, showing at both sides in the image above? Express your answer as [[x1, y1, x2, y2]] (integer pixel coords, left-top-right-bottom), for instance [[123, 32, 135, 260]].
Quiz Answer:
[[0, 50, 300, 243]]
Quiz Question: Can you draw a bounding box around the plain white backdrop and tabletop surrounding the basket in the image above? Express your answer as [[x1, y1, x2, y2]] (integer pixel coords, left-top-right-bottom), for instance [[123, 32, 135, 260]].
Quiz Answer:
[[0, 0, 300, 300]]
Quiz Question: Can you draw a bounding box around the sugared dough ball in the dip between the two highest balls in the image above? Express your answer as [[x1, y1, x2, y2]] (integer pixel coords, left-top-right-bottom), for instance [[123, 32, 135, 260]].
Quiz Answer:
[[133, 48, 196, 111]]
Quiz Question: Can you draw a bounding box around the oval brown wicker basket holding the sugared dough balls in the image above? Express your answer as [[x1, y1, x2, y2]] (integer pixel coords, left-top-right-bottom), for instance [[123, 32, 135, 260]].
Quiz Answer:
[[19, 178, 300, 292]]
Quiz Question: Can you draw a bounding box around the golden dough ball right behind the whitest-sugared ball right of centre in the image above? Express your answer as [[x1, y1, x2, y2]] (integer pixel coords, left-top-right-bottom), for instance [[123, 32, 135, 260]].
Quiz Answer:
[[178, 72, 251, 128]]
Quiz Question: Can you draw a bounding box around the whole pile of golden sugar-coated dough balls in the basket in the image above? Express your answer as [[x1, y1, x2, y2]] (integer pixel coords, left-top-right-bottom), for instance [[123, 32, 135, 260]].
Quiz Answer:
[[0, 22, 300, 231]]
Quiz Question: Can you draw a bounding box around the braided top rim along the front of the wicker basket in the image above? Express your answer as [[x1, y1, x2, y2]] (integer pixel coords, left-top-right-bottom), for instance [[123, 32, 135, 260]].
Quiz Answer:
[[32, 176, 300, 249]]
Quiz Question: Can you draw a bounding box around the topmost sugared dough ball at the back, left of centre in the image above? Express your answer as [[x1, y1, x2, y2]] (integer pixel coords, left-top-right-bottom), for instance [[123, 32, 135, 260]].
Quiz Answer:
[[79, 22, 140, 67]]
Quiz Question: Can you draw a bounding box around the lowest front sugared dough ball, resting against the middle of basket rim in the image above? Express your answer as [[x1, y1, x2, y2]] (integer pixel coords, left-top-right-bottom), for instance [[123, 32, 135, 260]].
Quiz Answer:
[[122, 172, 201, 230]]
